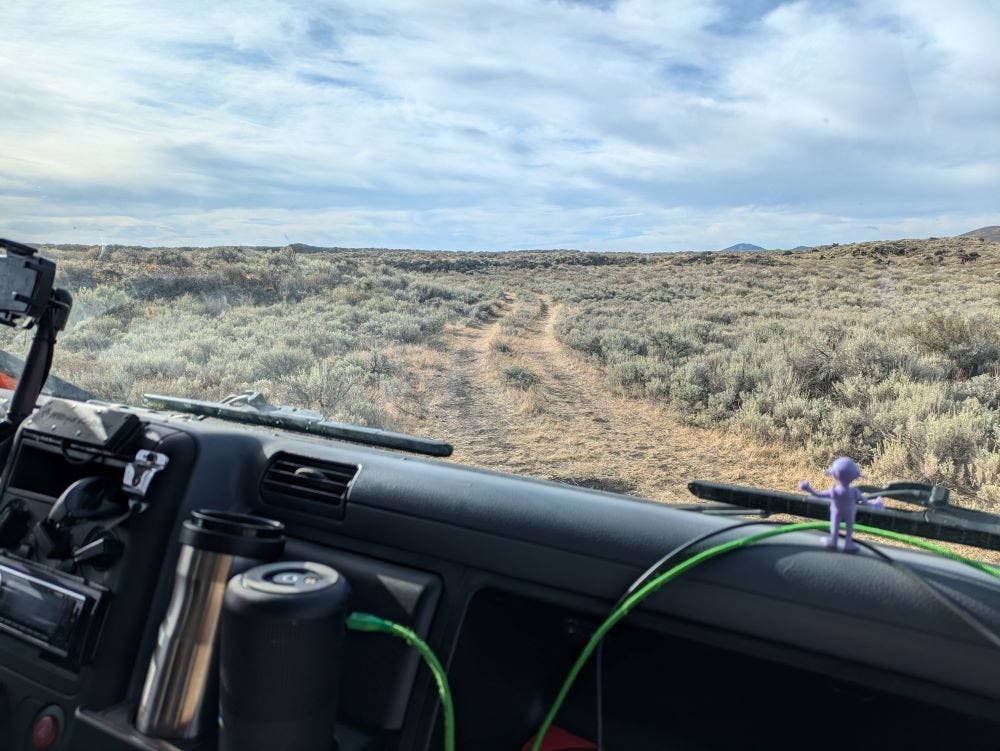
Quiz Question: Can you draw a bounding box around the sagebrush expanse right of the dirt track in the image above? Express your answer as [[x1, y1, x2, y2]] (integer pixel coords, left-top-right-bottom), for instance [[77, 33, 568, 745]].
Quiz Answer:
[[545, 239, 1000, 498]]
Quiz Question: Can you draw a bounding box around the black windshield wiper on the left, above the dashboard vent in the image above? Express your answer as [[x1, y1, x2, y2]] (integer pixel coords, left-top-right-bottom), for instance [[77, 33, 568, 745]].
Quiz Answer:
[[142, 391, 453, 456]]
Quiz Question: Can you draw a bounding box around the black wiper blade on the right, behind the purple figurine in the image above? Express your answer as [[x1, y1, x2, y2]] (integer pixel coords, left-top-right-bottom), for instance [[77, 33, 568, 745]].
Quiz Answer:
[[688, 480, 1000, 550]]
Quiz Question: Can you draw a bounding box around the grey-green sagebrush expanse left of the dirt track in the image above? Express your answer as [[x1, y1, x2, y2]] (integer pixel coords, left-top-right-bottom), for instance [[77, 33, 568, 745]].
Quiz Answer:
[[8, 246, 503, 427]]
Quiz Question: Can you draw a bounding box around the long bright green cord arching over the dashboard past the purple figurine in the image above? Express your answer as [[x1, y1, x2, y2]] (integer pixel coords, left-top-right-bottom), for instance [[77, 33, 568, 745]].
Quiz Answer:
[[531, 522, 1000, 751]]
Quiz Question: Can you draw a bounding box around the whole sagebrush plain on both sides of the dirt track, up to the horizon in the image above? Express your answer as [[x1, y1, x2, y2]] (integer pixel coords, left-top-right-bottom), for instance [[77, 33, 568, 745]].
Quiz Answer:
[[11, 238, 1000, 502]]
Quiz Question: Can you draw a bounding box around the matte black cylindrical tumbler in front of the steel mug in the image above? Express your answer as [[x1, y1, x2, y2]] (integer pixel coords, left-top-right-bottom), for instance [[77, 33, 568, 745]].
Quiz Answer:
[[219, 561, 350, 751]]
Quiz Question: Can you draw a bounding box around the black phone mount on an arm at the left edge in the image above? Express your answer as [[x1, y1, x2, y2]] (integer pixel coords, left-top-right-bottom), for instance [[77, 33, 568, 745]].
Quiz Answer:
[[0, 238, 73, 441]]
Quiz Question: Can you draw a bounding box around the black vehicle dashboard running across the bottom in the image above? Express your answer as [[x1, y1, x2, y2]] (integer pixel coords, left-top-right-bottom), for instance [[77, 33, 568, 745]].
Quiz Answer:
[[0, 400, 1000, 751]]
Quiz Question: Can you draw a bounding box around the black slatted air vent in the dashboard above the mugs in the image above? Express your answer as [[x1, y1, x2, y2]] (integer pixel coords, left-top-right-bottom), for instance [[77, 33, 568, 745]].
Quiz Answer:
[[260, 453, 360, 518]]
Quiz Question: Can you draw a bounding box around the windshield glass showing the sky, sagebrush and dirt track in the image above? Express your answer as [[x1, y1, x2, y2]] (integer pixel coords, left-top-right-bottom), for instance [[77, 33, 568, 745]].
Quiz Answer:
[[0, 0, 1000, 540]]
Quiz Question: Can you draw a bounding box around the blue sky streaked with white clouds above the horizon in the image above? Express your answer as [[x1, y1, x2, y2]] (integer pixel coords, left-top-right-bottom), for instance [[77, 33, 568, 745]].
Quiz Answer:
[[0, 0, 1000, 251]]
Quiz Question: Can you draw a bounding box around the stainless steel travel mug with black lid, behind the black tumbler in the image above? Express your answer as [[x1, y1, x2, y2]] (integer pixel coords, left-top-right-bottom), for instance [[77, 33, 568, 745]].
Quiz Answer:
[[135, 510, 285, 738]]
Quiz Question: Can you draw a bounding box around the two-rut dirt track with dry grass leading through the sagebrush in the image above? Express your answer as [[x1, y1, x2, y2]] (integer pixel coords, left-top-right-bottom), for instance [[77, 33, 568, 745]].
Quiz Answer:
[[418, 299, 818, 502]]
